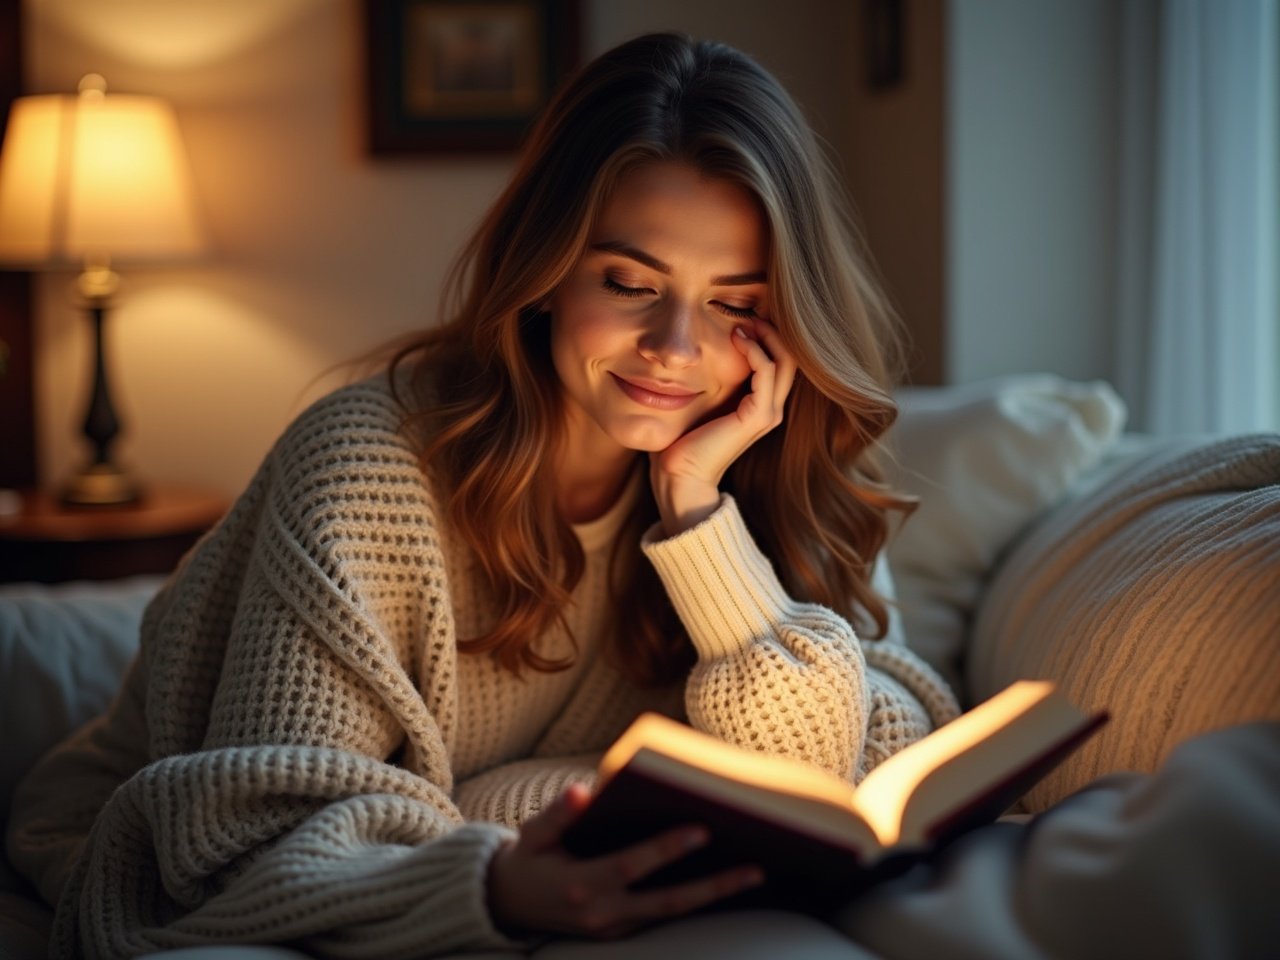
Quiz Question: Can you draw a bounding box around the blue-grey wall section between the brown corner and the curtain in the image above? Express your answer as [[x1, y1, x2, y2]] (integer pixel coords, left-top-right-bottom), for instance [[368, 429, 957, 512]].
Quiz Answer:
[[946, 0, 1119, 383]]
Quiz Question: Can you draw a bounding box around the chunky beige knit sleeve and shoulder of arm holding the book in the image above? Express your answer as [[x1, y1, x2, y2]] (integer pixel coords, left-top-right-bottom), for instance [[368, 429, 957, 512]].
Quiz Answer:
[[6, 387, 515, 957]]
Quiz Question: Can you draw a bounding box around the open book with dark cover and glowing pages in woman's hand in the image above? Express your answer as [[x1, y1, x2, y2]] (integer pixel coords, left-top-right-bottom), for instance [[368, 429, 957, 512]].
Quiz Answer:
[[563, 681, 1107, 910]]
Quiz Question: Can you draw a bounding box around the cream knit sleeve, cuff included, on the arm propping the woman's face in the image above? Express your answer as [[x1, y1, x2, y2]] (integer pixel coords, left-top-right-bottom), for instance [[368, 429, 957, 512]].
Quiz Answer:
[[641, 495, 959, 781]]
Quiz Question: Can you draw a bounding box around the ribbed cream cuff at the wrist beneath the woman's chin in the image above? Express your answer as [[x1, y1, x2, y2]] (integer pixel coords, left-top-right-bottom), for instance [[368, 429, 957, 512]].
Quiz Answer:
[[640, 494, 790, 659]]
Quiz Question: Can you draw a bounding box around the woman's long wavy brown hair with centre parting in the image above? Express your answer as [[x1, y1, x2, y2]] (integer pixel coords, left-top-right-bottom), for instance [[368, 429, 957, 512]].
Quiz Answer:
[[392, 33, 911, 682]]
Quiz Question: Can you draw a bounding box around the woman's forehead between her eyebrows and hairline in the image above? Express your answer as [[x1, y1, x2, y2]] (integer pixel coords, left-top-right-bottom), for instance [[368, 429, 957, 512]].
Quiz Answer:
[[591, 164, 768, 264]]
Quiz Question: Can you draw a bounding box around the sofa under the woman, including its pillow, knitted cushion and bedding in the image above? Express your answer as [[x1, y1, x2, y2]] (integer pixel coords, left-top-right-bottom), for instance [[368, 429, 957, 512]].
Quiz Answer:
[[0, 375, 1280, 960]]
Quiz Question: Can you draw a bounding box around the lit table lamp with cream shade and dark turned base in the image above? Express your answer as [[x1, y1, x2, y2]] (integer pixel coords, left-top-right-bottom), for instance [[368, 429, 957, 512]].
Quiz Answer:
[[0, 74, 204, 504]]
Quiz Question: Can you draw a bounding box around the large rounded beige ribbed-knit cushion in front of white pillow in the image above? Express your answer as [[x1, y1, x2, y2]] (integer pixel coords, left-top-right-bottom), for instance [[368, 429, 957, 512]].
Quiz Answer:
[[966, 434, 1280, 812]]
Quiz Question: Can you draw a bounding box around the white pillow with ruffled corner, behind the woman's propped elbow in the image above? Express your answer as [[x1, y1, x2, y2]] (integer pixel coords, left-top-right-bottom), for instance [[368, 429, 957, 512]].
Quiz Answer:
[[887, 374, 1125, 700]]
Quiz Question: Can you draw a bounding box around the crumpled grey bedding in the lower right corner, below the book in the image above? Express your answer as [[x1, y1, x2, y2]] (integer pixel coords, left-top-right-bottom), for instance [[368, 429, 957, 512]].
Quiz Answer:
[[837, 723, 1280, 960]]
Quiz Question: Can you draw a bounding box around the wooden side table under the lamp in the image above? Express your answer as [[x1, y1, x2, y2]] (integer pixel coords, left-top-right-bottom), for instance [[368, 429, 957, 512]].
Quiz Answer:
[[0, 484, 229, 584]]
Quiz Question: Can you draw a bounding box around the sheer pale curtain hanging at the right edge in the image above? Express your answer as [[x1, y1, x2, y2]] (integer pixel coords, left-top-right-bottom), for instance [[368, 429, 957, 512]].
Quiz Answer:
[[1116, 0, 1280, 434]]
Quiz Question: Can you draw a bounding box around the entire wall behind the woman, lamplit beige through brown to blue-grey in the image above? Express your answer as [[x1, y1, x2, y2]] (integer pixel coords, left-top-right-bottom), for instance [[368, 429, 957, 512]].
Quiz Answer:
[[26, 0, 1131, 494]]
